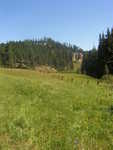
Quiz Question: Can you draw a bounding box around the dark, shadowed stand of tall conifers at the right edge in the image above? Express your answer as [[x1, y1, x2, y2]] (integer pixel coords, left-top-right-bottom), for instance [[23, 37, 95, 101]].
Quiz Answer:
[[81, 28, 113, 78]]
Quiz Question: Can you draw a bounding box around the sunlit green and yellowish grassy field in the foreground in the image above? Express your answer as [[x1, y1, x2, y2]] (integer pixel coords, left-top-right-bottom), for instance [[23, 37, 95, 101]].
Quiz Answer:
[[0, 69, 113, 150]]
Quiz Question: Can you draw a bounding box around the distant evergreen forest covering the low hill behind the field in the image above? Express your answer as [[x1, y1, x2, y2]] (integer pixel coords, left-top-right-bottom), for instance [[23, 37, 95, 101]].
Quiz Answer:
[[0, 38, 80, 70]]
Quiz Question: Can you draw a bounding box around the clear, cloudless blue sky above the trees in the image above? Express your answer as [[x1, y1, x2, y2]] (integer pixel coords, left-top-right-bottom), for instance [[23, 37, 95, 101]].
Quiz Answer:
[[0, 0, 113, 49]]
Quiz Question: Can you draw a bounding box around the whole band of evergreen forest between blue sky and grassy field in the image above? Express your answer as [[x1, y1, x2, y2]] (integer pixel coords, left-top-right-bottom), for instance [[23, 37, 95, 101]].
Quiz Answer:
[[0, 28, 113, 78]]
